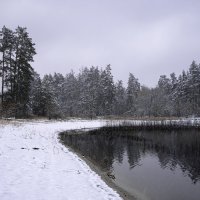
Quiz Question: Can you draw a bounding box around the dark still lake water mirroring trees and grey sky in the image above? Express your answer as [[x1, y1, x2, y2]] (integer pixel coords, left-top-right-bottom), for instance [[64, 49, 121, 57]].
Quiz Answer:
[[61, 128, 200, 200]]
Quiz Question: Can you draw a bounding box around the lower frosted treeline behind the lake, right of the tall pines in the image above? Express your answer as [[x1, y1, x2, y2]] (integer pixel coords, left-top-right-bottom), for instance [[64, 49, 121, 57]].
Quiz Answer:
[[28, 61, 200, 118]]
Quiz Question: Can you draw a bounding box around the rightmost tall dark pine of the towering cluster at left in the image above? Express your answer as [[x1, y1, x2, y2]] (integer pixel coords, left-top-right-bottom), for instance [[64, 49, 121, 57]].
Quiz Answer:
[[14, 27, 36, 115]]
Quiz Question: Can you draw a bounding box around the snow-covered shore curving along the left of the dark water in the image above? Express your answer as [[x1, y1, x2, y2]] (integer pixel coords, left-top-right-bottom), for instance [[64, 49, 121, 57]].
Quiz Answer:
[[0, 121, 121, 200]]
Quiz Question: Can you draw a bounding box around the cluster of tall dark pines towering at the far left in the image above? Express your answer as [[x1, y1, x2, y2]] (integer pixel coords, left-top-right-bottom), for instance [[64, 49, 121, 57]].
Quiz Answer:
[[0, 26, 36, 116]]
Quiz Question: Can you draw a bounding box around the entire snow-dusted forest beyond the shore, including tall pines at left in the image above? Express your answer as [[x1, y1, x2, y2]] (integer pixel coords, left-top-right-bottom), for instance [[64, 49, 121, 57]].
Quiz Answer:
[[0, 26, 200, 118]]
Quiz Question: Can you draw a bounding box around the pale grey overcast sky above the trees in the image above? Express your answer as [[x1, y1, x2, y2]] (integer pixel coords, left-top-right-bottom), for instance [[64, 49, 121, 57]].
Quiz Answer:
[[0, 0, 200, 86]]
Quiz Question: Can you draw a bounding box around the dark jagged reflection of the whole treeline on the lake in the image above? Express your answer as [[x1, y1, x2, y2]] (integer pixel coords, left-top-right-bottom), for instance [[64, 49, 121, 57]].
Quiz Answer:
[[62, 128, 200, 183]]
